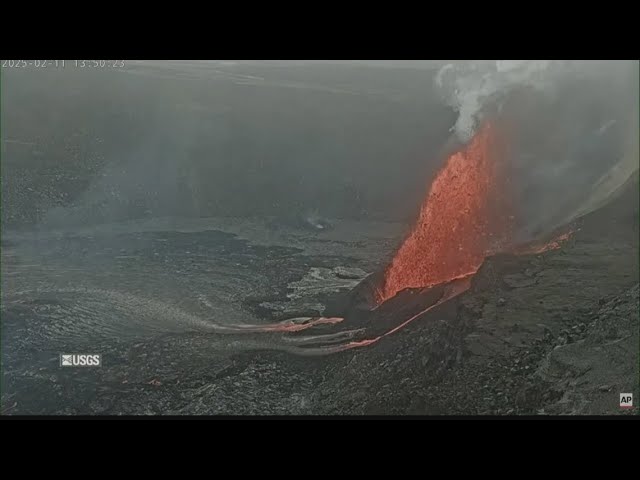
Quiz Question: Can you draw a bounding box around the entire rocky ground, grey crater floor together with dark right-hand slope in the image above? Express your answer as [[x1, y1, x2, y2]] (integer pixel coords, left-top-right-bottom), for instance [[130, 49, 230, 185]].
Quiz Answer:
[[2, 182, 640, 415]]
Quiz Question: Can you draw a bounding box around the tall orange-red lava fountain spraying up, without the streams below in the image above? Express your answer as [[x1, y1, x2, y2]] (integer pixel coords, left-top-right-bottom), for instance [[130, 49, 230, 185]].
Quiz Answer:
[[376, 123, 513, 304]]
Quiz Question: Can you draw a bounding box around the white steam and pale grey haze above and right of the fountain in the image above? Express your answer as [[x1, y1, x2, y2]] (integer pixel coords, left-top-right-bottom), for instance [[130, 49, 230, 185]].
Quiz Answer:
[[435, 60, 639, 239]]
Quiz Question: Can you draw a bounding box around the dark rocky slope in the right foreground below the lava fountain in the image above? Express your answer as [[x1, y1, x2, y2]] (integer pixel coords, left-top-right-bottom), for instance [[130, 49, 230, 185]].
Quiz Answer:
[[304, 182, 639, 415]]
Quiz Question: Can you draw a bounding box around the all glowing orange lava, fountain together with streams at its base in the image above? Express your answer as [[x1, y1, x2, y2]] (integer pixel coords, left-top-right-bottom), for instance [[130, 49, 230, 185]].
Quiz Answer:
[[206, 122, 573, 355]]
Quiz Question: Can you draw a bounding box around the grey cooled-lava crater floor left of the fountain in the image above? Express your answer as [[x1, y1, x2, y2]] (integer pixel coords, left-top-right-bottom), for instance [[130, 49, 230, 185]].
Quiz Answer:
[[2, 219, 404, 415]]
